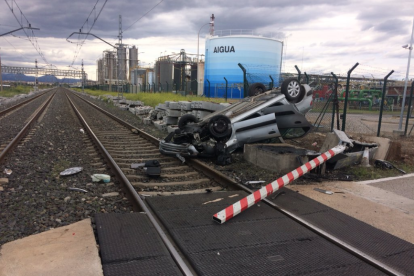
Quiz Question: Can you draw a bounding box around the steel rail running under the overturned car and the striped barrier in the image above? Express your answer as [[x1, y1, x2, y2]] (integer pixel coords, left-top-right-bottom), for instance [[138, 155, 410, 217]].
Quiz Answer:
[[68, 89, 404, 275]]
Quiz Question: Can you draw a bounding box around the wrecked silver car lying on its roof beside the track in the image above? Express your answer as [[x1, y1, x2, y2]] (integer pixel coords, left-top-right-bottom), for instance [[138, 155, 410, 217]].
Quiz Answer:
[[159, 78, 312, 165]]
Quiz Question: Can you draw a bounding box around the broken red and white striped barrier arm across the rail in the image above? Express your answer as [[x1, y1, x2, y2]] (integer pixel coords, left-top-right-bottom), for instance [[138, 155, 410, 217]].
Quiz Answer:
[[213, 145, 346, 224]]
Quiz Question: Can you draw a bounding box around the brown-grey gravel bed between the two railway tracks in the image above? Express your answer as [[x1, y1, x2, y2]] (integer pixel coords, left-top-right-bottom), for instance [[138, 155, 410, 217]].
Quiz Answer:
[[0, 91, 131, 245]]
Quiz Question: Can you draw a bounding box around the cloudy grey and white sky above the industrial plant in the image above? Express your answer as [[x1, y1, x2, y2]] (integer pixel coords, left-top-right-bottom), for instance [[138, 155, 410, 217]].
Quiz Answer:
[[0, 0, 414, 80]]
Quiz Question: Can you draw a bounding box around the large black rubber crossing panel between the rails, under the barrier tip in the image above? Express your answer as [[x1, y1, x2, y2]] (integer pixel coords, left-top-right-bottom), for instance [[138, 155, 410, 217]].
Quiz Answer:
[[146, 191, 384, 275]]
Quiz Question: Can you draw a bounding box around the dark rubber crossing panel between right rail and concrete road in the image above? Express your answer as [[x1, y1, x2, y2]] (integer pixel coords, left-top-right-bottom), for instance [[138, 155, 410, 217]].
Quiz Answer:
[[273, 188, 414, 275]]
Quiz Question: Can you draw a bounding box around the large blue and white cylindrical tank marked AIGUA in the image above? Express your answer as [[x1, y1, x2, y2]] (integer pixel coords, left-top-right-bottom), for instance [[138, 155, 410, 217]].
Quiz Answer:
[[204, 34, 283, 98]]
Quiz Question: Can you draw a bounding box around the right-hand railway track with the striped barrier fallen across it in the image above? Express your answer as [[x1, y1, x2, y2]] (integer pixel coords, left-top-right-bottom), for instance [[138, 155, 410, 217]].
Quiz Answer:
[[1, 87, 413, 275]]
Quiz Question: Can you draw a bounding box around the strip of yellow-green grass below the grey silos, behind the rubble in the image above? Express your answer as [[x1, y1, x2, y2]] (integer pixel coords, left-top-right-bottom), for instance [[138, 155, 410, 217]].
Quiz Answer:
[[74, 89, 226, 107]]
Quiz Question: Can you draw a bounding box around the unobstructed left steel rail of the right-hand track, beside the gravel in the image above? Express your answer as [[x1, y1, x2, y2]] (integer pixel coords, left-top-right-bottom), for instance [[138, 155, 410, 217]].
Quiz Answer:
[[66, 94, 193, 276]]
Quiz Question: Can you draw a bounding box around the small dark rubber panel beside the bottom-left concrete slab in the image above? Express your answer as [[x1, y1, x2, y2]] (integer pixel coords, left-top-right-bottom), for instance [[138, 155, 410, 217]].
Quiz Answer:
[[95, 213, 182, 276]]
